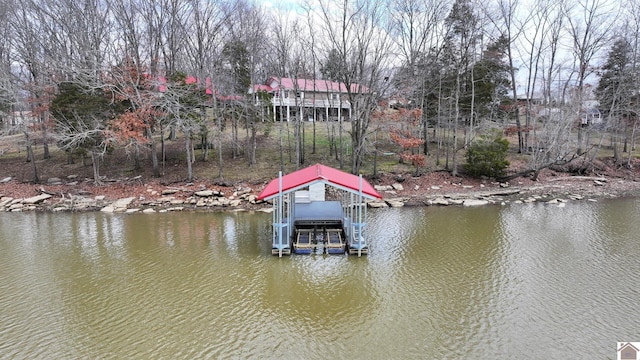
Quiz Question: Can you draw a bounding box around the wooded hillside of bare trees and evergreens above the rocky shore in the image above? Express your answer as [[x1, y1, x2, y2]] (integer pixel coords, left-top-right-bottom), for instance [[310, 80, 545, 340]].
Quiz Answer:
[[0, 0, 640, 186]]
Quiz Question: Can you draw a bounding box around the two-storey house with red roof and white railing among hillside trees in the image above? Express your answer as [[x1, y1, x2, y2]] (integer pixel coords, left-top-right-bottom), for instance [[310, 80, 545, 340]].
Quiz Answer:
[[250, 77, 369, 121]]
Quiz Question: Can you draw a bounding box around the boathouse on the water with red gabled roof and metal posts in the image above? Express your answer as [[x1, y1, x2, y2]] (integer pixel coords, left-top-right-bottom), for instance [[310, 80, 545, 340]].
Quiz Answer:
[[258, 164, 382, 256]]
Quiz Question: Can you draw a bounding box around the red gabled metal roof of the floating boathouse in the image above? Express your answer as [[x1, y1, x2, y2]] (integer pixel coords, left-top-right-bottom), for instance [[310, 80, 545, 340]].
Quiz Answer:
[[258, 164, 382, 200]]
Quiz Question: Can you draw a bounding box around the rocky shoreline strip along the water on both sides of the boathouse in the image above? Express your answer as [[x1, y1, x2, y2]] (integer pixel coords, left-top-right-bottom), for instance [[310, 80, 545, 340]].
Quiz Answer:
[[0, 176, 640, 214]]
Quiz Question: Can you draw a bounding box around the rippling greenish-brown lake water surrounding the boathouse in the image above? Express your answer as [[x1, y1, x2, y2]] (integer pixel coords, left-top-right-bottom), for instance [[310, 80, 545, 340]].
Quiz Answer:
[[0, 199, 640, 359]]
